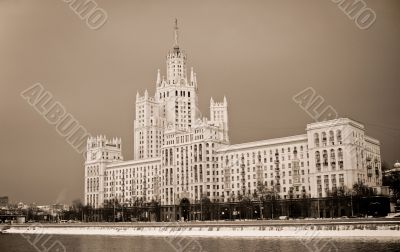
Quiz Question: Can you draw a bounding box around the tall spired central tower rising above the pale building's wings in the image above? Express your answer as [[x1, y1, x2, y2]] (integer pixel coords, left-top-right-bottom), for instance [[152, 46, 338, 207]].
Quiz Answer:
[[134, 19, 200, 159]]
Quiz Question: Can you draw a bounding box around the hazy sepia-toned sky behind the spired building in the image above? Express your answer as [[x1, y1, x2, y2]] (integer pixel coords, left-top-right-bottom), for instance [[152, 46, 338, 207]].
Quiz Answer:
[[0, 0, 400, 204]]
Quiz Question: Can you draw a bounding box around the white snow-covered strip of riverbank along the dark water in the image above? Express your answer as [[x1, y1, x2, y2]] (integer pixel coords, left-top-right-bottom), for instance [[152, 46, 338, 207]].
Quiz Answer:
[[3, 224, 400, 237]]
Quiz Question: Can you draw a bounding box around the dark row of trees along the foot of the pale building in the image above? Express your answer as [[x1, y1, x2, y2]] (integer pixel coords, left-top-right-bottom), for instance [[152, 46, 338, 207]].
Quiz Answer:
[[57, 180, 386, 221]]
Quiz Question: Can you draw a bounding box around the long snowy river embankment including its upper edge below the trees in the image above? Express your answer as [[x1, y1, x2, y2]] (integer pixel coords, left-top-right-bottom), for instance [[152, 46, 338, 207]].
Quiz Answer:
[[1, 219, 400, 238]]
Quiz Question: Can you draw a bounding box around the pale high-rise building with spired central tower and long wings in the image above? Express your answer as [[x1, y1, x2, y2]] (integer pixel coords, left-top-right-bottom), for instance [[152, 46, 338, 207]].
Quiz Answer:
[[85, 20, 382, 219]]
